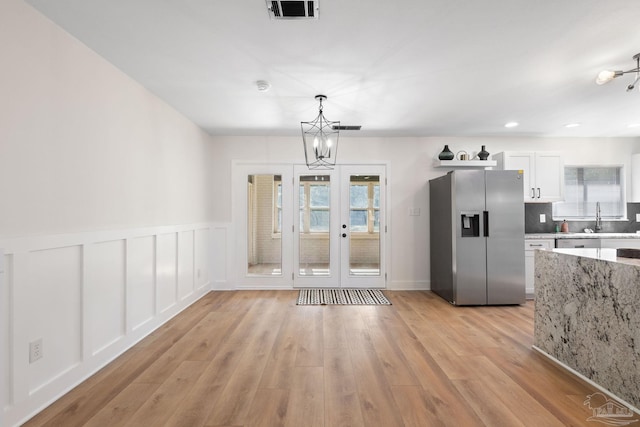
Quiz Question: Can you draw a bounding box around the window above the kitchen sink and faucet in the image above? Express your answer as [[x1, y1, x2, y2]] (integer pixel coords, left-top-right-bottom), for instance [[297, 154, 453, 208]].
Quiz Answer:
[[553, 166, 627, 220]]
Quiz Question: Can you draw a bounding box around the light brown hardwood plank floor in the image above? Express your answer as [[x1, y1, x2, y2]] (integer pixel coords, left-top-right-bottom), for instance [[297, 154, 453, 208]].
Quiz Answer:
[[26, 291, 640, 427]]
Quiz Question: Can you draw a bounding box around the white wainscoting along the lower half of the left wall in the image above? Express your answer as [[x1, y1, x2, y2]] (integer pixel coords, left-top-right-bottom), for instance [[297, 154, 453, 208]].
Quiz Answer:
[[0, 224, 215, 426]]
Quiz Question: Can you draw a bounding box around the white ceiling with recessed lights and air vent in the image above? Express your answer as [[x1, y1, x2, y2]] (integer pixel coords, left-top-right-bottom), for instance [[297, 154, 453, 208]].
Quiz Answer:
[[27, 0, 640, 137]]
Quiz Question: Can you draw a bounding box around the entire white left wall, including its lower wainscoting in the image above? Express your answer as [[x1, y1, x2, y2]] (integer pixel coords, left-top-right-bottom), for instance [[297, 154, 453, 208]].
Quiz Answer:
[[0, 0, 218, 425]]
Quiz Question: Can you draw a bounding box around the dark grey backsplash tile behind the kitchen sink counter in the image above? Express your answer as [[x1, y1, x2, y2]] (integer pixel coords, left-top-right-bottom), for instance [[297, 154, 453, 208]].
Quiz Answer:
[[524, 203, 640, 233]]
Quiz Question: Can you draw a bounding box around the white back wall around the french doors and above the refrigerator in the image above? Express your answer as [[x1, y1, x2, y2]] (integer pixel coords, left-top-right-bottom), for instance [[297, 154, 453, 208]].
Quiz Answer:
[[208, 137, 640, 289]]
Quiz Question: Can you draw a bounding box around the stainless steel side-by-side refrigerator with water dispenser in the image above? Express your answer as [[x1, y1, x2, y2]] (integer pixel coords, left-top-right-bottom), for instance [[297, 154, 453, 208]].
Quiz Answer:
[[429, 170, 525, 305]]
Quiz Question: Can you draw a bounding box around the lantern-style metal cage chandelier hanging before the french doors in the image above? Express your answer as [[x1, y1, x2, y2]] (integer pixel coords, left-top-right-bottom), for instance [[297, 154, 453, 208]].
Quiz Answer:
[[300, 95, 340, 169]]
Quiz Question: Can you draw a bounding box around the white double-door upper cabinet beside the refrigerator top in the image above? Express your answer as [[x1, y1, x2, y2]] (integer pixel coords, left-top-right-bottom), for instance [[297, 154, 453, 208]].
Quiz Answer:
[[493, 151, 564, 203]]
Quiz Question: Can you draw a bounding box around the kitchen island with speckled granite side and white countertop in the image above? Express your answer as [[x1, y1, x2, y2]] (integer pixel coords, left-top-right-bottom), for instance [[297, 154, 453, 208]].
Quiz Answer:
[[534, 249, 640, 411]]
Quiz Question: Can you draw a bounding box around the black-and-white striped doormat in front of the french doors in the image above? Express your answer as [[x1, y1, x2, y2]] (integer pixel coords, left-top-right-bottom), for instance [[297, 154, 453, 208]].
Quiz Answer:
[[296, 289, 391, 305]]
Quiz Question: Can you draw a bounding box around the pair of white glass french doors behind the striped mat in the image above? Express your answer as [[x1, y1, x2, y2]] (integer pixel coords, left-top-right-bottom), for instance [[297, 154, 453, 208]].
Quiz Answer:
[[292, 165, 386, 288]]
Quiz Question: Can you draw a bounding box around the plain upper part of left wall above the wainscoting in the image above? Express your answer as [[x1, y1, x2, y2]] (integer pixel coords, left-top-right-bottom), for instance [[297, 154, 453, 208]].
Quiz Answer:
[[0, 0, 213, 237]]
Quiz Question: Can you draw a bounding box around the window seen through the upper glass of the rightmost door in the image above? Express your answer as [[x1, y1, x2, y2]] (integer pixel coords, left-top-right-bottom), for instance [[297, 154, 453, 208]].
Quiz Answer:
[[349, 176, 380, 233]]
